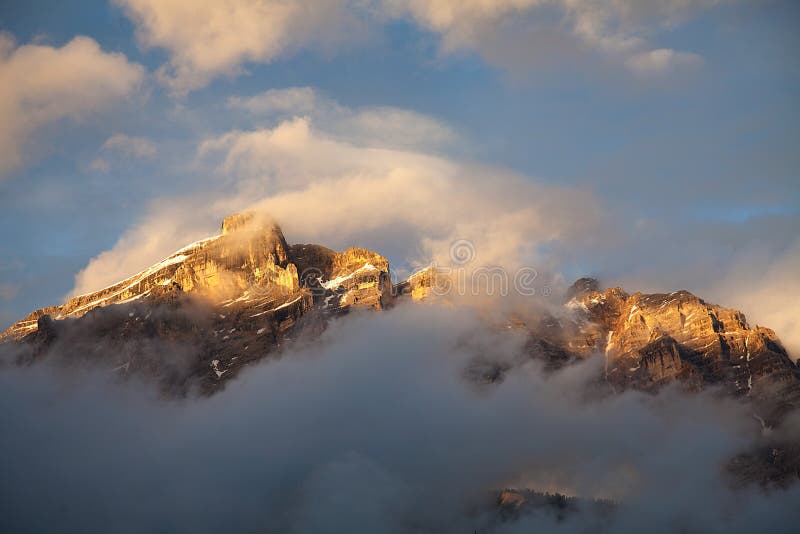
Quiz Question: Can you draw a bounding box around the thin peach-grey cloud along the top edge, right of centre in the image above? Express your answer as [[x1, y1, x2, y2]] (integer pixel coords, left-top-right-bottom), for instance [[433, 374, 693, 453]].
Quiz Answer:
[[384, 0, 724, 74]]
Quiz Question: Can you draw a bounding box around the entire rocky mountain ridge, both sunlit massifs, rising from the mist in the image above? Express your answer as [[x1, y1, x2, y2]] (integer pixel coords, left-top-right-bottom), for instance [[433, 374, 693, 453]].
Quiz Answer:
[[0, 212, 800, 484]]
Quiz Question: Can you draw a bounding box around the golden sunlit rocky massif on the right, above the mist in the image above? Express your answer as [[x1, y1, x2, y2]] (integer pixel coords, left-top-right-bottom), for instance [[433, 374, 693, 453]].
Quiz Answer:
[[567, 280, 798, 406]]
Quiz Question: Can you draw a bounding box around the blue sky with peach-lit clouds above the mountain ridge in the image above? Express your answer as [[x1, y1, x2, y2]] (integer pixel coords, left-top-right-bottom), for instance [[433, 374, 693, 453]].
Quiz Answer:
[[0, 0, 800, 354]]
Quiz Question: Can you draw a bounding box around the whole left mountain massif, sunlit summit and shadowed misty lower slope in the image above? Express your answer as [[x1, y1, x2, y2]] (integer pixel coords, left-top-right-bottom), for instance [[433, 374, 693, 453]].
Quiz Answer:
[[0, 213, 391, 393]]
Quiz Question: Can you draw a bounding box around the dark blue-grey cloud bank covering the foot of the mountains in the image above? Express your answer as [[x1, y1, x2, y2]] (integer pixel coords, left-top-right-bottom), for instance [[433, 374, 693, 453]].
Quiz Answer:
[[0, 305, 798, 533]]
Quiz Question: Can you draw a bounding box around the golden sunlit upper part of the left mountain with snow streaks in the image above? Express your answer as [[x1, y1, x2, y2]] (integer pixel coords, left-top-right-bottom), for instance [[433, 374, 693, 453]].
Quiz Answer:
[[0, 211, 391, 340]]
